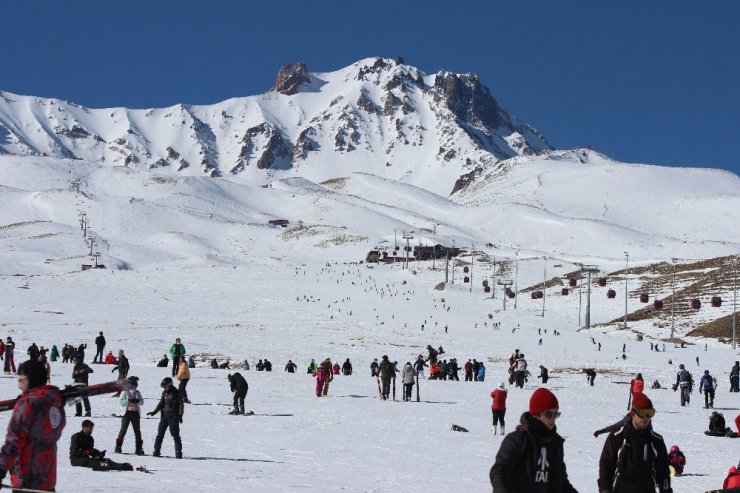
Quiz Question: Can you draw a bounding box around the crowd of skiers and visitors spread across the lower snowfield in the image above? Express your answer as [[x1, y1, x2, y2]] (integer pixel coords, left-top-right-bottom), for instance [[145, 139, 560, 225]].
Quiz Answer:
[[0, 324, 740, 493]]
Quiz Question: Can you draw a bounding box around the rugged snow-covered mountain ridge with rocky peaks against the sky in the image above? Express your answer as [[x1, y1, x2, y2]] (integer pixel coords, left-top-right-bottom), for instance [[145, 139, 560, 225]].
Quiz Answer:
[[0, 58, 550, 195]]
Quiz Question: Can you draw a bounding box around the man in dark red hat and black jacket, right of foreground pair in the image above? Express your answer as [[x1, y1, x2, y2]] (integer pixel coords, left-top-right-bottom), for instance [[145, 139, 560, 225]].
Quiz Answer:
[[598, 393, 673, 493]]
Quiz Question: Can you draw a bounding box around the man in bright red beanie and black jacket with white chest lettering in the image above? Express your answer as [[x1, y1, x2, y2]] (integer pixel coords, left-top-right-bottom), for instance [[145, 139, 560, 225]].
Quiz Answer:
[[489, 388, 576, 493]]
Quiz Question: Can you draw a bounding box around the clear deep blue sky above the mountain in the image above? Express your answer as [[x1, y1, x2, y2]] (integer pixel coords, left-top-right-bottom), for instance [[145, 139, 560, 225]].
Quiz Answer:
[[0, 0, 740, 174]]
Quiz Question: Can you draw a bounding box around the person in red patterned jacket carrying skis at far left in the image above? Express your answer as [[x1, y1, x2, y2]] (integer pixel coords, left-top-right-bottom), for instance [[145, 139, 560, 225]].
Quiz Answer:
[[0, 360, 66, 491]]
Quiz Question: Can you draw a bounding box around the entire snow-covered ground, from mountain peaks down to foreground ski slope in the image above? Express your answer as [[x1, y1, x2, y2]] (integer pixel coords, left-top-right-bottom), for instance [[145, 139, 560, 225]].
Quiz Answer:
[[0, 59, 740, 493]]
